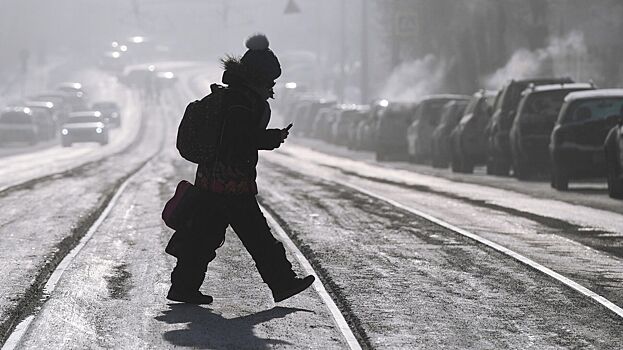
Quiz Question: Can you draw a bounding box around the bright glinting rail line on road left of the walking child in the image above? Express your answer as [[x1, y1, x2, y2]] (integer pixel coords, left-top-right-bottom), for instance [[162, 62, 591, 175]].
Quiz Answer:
[[2, 162, 142, 350]]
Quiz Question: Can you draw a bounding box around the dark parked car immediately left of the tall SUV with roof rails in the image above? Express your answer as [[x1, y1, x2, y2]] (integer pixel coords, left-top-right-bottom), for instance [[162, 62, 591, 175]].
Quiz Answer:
[[450, 90, 500, 173]]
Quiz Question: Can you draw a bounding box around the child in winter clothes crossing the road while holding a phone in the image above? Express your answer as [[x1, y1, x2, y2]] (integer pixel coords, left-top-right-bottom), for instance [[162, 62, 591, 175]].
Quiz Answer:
[[166, 34, 314, 304]]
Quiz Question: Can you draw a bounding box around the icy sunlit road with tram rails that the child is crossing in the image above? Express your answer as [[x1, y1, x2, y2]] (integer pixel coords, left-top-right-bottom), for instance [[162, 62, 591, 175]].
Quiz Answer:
[[0, 65, 623, 349]]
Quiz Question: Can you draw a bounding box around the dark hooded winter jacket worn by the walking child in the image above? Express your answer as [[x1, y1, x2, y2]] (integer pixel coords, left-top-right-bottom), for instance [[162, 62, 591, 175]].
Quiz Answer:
[[195, 59, 281, 195]]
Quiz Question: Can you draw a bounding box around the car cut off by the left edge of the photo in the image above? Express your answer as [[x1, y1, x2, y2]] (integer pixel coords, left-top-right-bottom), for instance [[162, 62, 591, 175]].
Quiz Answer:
[[0, 107, 39, 145]]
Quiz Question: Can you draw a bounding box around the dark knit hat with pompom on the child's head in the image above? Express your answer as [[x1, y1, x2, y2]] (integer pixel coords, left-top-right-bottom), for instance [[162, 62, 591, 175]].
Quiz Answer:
[[240, 34, 281, 83]]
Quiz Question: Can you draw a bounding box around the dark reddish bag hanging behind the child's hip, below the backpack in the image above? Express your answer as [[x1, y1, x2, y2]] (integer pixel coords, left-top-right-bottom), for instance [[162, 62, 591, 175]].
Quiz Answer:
[[162, 180, 202, 230]]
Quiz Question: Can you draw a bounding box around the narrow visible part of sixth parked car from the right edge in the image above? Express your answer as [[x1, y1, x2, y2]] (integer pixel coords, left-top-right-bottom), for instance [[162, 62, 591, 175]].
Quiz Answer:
[[431, 100, 469, 168]]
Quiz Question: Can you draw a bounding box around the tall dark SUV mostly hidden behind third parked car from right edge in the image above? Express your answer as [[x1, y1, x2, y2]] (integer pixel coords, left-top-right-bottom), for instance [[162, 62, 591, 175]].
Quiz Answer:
[[486, 78, 573, 176]]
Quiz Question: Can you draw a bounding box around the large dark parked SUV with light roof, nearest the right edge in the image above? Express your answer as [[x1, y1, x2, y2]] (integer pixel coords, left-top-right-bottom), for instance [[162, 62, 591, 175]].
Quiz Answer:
[[549, 89, 623, 191]]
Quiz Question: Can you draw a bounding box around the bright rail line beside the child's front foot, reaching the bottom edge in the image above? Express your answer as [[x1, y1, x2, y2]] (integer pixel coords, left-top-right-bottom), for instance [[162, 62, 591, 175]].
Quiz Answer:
[[260, 206, 361, 350]]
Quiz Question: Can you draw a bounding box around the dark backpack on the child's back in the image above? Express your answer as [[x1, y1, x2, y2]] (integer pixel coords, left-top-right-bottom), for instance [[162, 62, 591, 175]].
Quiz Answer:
[[176, 84, 227, 164]]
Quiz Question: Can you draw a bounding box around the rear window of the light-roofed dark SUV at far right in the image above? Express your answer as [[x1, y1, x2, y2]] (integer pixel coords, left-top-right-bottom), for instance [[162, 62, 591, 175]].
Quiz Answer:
[[563, 97, 623, 122]]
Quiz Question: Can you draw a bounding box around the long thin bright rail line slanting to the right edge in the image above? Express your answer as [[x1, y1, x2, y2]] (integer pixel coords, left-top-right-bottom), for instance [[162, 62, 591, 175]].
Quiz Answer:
[[340, 182, 623, 318]]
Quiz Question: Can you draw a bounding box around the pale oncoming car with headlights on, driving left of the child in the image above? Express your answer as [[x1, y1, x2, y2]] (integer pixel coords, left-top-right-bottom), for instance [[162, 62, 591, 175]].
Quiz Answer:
[[61, 111, 109, 147]]
